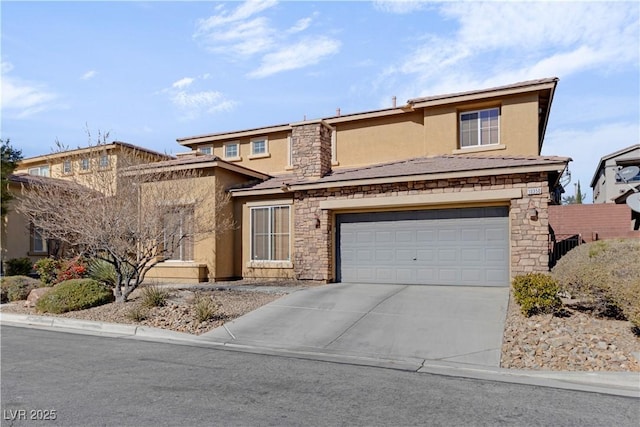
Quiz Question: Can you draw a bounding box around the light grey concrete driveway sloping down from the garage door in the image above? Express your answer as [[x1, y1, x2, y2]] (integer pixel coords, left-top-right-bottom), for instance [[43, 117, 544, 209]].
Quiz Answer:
[[201, 283, 509, 367]]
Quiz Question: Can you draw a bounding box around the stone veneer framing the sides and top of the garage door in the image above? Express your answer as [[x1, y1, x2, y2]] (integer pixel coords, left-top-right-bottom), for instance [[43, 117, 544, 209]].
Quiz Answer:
[[293, 173, 549, 282]]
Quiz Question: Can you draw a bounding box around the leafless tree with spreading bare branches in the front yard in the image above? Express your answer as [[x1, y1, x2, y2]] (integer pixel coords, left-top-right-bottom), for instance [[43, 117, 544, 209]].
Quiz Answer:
[[17, 144, 233, 302]]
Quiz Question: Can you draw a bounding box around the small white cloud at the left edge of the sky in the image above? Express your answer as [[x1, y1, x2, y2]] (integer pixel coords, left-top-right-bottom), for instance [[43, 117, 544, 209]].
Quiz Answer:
[[1, 61, 58, 119]]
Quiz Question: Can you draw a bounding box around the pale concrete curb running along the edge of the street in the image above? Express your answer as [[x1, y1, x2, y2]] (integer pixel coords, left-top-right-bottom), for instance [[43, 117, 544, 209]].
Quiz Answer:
[[0, 312, 640, 398]]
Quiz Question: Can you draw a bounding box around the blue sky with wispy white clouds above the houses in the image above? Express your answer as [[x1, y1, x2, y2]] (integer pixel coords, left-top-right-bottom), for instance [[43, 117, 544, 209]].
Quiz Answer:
[[0, 0, 640, 200]]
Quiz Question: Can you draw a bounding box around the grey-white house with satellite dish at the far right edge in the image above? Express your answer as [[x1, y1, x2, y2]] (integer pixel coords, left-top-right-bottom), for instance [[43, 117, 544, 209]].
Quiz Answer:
[[591, 144, 640, 204]]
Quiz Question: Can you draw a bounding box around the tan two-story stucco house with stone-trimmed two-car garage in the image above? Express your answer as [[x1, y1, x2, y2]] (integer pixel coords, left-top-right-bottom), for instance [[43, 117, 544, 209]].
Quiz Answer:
[[139, 78, 570, 286]]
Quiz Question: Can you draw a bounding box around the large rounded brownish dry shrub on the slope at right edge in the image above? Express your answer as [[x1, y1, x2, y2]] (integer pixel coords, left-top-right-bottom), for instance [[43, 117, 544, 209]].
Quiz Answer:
[[552, 239, 640, 327]]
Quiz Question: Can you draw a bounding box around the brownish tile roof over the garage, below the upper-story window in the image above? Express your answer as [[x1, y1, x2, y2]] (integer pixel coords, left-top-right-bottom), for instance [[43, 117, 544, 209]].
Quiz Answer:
[[236, 155, 571, 191]]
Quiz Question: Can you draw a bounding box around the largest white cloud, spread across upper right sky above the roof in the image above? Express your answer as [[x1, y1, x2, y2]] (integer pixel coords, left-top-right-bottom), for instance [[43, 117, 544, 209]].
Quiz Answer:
[[383, 2, 640, 97]]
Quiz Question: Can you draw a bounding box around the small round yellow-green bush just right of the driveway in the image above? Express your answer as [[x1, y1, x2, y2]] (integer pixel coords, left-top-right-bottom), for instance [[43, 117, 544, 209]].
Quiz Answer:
[[513, 273, 562, 316]]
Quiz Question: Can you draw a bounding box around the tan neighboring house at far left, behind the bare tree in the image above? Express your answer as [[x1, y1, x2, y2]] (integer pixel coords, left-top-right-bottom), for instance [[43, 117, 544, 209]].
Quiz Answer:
[[0, 142, 173, 270]]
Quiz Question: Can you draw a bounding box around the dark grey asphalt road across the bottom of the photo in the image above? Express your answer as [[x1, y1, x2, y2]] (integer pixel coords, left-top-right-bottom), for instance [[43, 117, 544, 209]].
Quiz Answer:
[[0, 326, 640, 426]]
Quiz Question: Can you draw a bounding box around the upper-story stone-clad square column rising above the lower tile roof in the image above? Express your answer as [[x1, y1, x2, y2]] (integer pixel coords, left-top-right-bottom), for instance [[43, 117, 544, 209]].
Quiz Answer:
[[291, 121, 331, 180]]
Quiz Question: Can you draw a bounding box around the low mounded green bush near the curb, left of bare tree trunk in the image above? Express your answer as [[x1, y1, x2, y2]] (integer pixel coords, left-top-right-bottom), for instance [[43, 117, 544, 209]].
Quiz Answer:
[[36, 279, 115, 313]]
